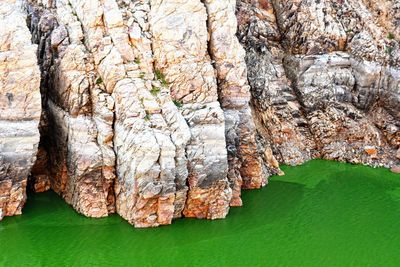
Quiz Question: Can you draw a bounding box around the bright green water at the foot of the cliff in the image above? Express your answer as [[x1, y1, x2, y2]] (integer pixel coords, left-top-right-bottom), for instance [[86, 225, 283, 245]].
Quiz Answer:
[[0, 160, 400, 267]]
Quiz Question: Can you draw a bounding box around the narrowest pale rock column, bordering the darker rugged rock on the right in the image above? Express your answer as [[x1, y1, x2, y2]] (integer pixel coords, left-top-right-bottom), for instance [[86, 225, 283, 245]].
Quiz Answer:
[[202, 0, 266, 206]]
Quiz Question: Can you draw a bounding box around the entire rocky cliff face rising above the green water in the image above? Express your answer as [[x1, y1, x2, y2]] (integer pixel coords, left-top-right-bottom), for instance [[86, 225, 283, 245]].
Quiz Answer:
[[0, 0, 400, 227]]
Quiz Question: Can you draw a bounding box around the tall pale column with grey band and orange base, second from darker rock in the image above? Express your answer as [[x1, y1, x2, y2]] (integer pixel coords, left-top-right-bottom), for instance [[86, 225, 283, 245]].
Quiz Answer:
[[150, 0, 231, 219]]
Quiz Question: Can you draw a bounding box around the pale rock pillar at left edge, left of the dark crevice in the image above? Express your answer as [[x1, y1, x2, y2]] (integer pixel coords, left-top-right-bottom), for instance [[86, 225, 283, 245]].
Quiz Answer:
[[0, 0, 41, 220]]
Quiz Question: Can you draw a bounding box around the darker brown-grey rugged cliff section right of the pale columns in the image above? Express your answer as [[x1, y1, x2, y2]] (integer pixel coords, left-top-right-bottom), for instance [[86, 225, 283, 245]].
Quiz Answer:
[[237, 0, 400, 170]]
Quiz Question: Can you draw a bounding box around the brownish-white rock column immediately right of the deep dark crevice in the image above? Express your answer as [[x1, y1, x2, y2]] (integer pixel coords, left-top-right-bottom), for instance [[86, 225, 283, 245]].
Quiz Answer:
[[30, 0, 115, 220]]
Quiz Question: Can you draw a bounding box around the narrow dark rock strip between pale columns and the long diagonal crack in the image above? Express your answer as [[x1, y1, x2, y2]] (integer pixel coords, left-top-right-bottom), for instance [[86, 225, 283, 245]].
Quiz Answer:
[[237, 1, 313, 170]]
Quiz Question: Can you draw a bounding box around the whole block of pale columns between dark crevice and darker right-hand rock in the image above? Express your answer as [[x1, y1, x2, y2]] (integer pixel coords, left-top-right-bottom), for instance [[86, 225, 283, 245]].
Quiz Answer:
[[21, 0, 266, 227]]
